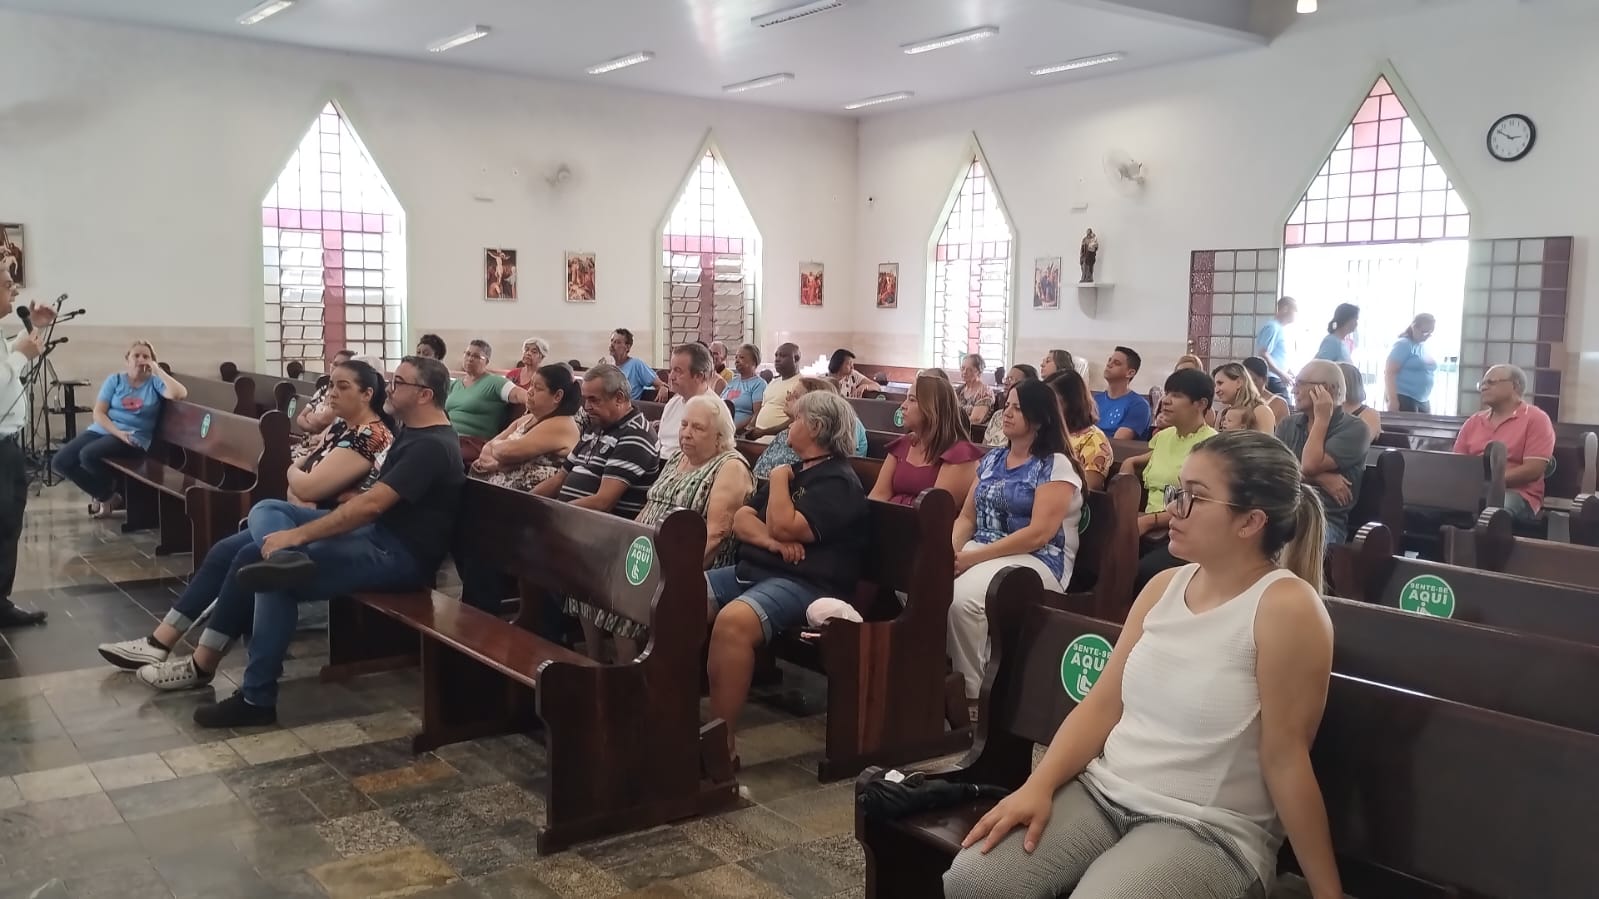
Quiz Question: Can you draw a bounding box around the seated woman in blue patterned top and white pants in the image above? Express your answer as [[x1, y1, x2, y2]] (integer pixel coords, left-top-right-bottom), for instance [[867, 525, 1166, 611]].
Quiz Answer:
[[948, 372, 1083, 702]]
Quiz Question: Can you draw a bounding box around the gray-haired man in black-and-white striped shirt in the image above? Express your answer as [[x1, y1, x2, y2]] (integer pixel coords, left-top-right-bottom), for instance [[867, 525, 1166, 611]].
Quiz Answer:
[[532, 365, 660, 518]]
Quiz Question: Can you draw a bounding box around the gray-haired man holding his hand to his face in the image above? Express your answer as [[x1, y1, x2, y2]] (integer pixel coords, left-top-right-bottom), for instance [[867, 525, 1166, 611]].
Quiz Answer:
[[1278, 360, 1372, 544]]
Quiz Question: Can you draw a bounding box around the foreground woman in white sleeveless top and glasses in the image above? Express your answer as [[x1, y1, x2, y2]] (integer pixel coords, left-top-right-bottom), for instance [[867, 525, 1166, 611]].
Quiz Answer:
[[943, 430, 1343, 899]]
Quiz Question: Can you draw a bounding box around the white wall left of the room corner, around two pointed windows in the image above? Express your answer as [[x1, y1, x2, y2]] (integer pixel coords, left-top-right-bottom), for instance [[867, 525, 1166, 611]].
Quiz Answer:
[[0, 13, 870, 376]]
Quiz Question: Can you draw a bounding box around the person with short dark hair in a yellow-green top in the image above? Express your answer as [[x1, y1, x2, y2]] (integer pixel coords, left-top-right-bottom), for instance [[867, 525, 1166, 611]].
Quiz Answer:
[[1121, 368, 1215, 590]]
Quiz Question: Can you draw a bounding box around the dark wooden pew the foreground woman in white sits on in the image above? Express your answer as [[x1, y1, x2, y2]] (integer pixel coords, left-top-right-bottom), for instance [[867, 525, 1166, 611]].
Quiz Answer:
[[855, 568, 1599, 899]]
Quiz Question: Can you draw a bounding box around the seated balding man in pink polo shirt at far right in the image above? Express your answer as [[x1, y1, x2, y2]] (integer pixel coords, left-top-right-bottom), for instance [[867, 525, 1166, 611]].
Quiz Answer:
[[1455, 365, 1554, 520]]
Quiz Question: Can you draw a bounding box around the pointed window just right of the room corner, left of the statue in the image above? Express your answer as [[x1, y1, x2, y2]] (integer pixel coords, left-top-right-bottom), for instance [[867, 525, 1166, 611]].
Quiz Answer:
[[929, 152, 1015, 368]]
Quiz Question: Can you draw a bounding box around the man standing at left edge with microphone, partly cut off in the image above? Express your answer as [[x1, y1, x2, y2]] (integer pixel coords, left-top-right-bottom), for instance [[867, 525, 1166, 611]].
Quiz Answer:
[[0, 266, 56, 627]]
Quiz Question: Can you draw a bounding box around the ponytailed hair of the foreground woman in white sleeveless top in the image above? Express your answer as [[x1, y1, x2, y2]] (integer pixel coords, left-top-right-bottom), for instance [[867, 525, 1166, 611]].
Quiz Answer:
[[1193, 430, 1327, 593]]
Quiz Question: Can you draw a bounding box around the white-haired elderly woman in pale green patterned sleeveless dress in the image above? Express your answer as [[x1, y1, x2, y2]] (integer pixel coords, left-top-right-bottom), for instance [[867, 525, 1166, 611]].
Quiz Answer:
[[571, 394, 755, 659]]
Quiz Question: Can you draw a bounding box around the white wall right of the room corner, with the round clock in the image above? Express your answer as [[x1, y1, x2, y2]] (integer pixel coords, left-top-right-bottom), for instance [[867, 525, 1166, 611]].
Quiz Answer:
[[854, 0, 1599, 421]]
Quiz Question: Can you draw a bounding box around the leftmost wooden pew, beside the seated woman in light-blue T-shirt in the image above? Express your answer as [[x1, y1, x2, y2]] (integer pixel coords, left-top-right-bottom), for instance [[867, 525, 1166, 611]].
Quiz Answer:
[[106, 400, 289, 568]]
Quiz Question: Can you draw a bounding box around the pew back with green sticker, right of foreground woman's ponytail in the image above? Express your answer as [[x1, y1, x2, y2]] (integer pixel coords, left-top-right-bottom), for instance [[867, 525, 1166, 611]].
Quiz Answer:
[[1330, 525, 1599, 645]]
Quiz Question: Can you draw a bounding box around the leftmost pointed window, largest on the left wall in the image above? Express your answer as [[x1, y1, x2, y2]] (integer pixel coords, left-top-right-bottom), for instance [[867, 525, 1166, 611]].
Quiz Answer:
[[261, 102, 405, 371]]
